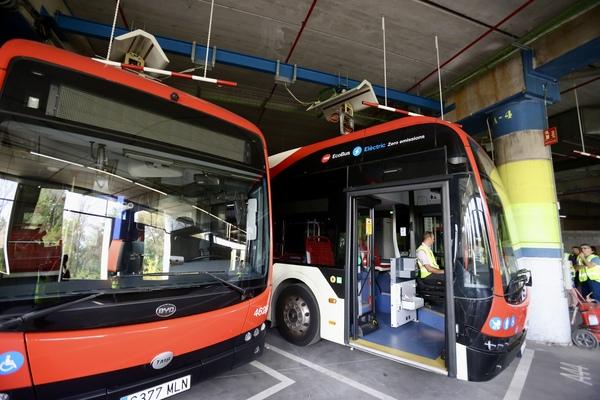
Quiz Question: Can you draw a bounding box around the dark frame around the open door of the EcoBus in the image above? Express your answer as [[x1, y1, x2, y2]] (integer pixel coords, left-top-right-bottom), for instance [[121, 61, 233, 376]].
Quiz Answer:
[[344, 177, 457, 378]]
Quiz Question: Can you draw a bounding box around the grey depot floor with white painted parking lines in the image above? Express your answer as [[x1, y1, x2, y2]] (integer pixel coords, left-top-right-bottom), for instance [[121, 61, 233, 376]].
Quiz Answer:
[[173, 329, 600, 400]]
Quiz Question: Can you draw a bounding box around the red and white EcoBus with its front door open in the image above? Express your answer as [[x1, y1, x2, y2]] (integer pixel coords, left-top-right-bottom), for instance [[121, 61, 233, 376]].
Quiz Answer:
[[270, 116, 529, 381]]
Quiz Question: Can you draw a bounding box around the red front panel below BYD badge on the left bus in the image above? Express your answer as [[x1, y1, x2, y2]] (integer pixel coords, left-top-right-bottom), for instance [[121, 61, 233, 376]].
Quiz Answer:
[[25, 302, 248, 385]]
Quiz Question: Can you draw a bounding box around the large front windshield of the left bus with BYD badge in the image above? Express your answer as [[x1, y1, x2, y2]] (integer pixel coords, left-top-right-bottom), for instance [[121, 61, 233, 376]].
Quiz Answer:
[[0, 60, 269, 308]]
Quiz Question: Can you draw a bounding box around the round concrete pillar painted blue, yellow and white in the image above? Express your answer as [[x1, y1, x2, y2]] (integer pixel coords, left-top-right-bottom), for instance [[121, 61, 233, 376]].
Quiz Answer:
[[489, 98, 571, 345]]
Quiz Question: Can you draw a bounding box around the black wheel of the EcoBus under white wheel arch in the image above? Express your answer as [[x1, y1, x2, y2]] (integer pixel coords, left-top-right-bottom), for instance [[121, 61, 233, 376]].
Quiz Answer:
[[275, 284, 321, 346]]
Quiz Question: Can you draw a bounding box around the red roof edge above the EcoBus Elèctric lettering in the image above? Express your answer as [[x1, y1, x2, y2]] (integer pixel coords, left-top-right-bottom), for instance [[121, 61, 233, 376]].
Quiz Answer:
[[269, 116, 468, 178]]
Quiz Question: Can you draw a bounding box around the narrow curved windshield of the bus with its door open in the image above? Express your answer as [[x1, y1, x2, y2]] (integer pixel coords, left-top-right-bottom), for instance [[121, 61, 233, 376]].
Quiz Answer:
[[471, 139, 518, 293]]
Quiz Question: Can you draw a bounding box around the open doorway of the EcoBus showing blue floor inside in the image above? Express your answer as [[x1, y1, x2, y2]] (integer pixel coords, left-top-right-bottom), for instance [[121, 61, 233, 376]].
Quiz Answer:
[[346, 181, 456, 376]]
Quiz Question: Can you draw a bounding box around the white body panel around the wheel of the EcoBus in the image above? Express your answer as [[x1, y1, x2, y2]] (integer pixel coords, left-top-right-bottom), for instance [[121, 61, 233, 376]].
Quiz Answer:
[[268, 263, 345, 345]]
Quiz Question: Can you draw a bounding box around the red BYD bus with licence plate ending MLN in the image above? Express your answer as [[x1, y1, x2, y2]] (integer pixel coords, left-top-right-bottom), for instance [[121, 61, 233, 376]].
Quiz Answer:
[[0, 40, 271, 400]]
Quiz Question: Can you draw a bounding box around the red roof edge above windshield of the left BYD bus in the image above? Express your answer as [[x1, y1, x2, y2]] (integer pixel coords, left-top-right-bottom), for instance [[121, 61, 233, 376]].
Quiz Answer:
[[0, 39, 266, 148]]
